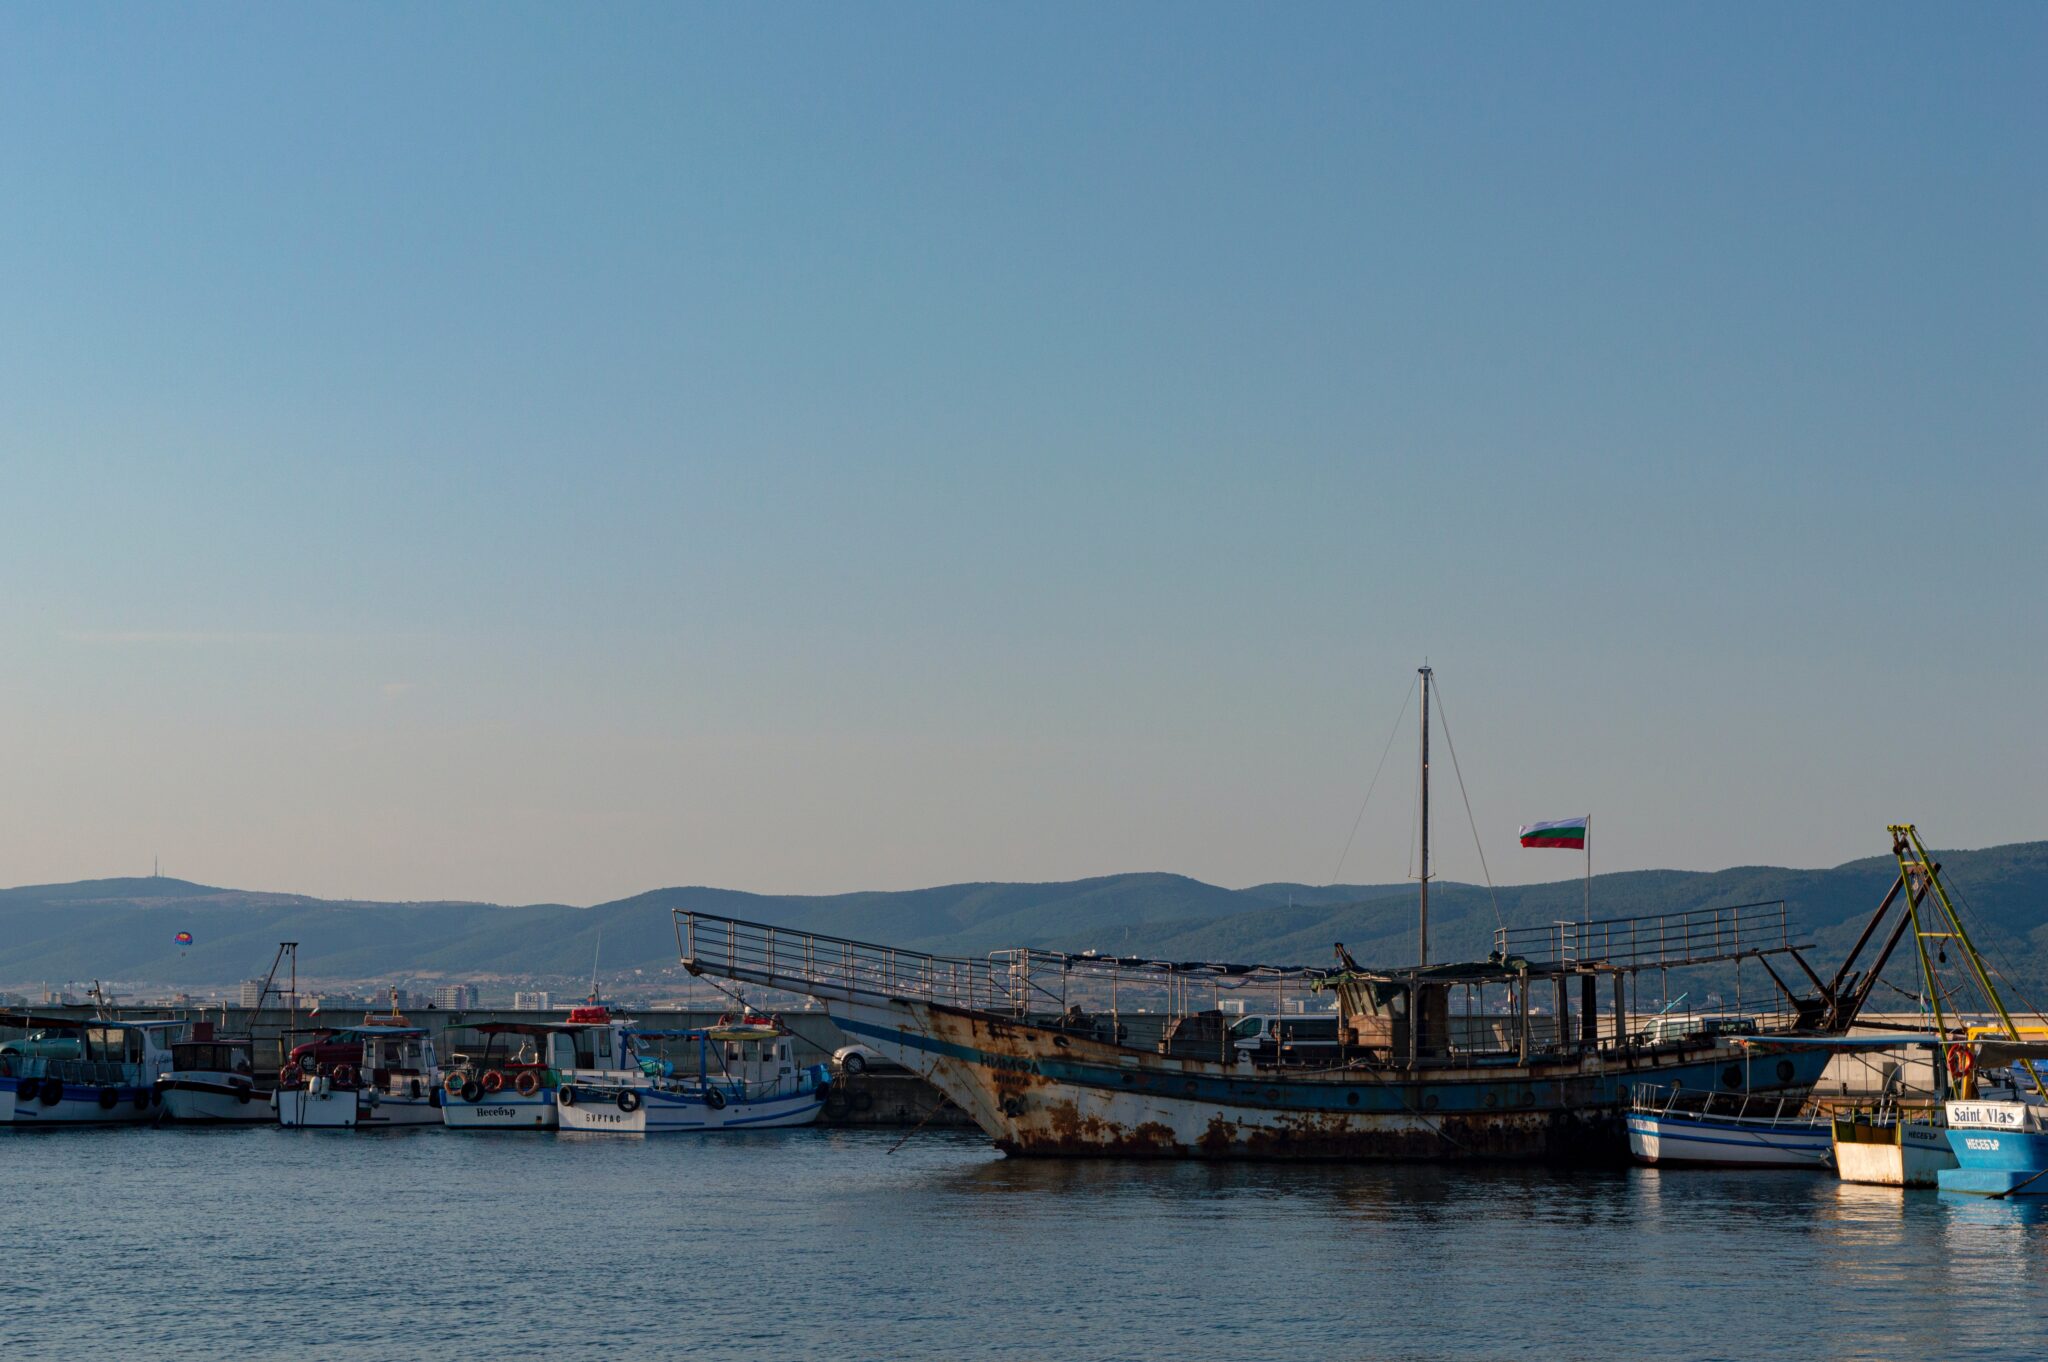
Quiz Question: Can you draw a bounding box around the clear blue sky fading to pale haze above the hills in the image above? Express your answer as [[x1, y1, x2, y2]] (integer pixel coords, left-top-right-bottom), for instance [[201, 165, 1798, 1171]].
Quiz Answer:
[[0, 4, 2048, 901]]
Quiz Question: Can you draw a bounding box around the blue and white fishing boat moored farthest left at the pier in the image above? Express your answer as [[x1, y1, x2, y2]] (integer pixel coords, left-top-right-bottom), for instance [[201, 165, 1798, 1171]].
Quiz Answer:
[[0, 1012, 186, 1126]]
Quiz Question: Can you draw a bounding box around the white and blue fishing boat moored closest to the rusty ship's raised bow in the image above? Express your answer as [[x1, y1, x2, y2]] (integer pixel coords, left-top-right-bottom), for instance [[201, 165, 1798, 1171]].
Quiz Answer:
[[555, 1016, 831, 1135]]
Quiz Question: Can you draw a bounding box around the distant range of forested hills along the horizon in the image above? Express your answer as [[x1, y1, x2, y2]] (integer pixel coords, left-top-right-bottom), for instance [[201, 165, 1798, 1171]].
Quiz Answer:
[[12, 842, 2048, 1002]]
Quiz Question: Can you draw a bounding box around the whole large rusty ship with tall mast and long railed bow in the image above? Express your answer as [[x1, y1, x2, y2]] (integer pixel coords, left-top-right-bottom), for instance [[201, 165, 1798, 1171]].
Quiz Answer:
[[674, 672, 1905, 1161]]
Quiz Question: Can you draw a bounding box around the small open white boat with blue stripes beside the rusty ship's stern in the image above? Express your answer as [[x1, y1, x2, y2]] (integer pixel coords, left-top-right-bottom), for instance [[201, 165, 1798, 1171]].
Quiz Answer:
[[1626, 1083, 1833, 1167]]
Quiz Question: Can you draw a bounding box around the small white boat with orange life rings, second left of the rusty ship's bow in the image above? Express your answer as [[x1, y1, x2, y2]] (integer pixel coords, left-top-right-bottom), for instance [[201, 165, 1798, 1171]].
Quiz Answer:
[[440, 1004, 635, 1131]]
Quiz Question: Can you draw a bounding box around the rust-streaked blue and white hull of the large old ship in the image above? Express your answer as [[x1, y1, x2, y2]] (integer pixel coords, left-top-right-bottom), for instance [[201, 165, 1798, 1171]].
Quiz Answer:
[[825, 997, 1827, 1163]]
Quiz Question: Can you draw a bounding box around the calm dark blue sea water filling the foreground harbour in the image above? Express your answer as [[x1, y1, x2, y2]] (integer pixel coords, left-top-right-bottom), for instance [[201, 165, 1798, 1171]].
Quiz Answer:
[[0, 1129, 2048, 1362]]
